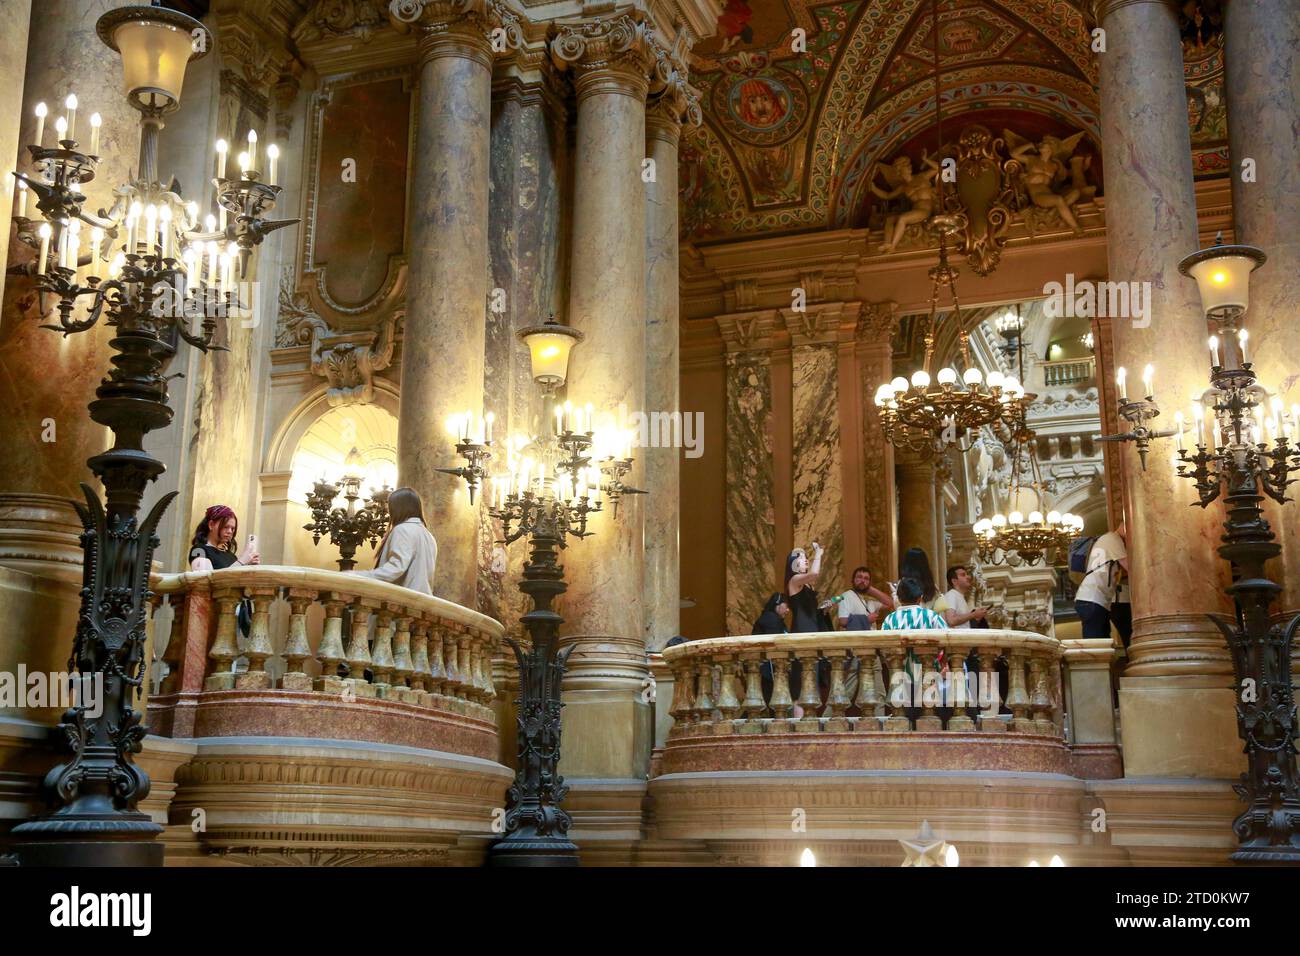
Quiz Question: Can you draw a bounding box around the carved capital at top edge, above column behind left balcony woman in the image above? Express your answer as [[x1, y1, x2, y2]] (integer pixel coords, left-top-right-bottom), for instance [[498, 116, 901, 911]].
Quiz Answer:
[[389, 0, 512, 69]]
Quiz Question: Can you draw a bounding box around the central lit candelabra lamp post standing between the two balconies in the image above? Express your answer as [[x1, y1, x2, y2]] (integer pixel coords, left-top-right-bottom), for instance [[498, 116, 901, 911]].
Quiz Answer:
[[439, 316, 645, 866]]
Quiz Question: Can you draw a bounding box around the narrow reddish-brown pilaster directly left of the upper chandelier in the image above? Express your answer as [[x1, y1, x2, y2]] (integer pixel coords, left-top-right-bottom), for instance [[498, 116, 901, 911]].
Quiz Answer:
[[855, 303, 898, 580]]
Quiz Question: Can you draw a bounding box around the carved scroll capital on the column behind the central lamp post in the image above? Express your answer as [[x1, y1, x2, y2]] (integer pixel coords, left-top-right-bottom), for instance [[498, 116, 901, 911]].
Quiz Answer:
[[550, 10, 671, 100]]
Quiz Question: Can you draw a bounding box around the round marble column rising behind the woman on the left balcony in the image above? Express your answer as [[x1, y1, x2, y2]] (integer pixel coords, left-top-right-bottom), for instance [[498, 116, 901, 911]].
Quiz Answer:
[[398, 0, 493, 607]]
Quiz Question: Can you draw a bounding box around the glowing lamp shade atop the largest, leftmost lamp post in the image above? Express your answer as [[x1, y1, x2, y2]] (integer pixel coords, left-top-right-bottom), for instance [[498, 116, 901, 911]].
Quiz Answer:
[[95, 7, 212, 109]]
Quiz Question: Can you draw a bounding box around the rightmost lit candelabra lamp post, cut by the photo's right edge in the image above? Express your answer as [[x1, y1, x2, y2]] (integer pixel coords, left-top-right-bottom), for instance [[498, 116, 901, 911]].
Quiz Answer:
[[1178, 245, 1300, 862]]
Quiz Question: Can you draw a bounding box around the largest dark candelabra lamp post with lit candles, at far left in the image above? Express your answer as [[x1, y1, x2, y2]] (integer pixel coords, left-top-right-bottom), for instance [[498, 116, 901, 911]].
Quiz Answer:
[[12, 7, 296, 866]]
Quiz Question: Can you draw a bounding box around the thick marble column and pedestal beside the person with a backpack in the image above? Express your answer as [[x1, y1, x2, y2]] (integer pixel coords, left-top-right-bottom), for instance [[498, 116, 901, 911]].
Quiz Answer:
[[1095, 0, 1242, 777]]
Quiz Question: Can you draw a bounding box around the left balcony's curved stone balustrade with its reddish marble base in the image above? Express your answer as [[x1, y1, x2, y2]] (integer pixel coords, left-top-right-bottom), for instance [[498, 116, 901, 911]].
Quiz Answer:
[[148, 566, 503, 760]]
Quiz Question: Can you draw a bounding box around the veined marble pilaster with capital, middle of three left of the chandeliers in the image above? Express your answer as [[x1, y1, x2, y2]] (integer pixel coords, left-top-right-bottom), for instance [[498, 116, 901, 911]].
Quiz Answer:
[[781, 302, 861, 597]]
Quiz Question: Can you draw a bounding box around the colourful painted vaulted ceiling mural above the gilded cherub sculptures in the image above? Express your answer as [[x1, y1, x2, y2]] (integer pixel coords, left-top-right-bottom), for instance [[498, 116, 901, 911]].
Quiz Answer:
[[681, 0, 1226, 241]]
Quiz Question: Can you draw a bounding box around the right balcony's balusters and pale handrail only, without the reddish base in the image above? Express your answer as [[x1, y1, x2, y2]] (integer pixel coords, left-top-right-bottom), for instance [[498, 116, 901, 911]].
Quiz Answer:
[[663, 628, 1062, 745]]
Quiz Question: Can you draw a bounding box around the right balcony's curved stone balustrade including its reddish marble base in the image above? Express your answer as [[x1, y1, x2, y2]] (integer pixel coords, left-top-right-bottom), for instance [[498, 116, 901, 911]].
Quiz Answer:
[[663, 630, 1070, 774]]
